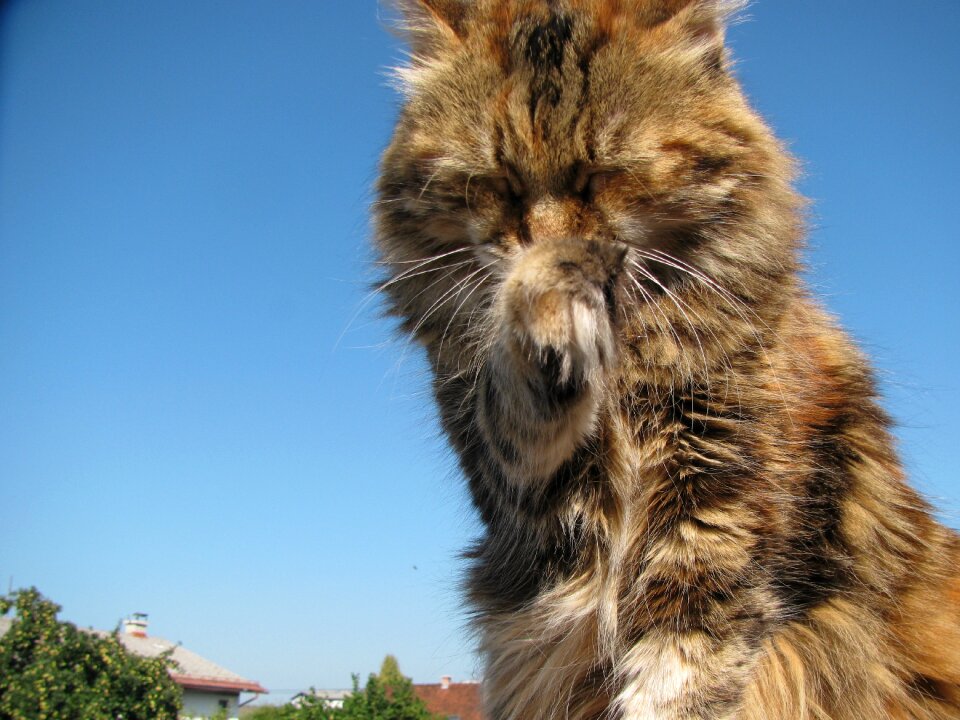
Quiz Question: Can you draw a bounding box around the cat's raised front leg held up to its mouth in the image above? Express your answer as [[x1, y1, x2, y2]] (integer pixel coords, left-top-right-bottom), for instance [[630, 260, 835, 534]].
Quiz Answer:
[[478, 240, 625, 482]]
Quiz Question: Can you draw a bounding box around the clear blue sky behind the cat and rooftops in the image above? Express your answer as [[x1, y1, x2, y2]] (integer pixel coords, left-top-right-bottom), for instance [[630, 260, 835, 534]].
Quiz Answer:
[[0, 0, 960, 695]]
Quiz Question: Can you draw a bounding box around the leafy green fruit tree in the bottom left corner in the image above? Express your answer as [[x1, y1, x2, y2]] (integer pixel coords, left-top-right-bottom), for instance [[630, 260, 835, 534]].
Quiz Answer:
[[0, 588, 182, 720]]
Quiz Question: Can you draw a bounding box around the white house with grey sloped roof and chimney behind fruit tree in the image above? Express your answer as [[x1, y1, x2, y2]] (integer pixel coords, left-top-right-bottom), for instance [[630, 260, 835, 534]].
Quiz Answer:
[[0, 613, 267, 720]]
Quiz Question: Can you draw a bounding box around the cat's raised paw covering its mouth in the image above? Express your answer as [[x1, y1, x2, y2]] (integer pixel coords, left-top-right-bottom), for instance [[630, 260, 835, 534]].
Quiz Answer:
[[502, 240, 625, 401]]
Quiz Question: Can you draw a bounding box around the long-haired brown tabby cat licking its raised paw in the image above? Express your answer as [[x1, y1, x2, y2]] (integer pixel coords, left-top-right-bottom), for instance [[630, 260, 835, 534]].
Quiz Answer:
[[376, 0, 960, 720]]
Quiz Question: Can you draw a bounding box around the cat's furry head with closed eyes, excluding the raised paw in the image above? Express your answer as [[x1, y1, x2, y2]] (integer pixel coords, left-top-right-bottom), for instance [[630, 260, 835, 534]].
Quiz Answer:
[[376, 0, 800, 380]]
